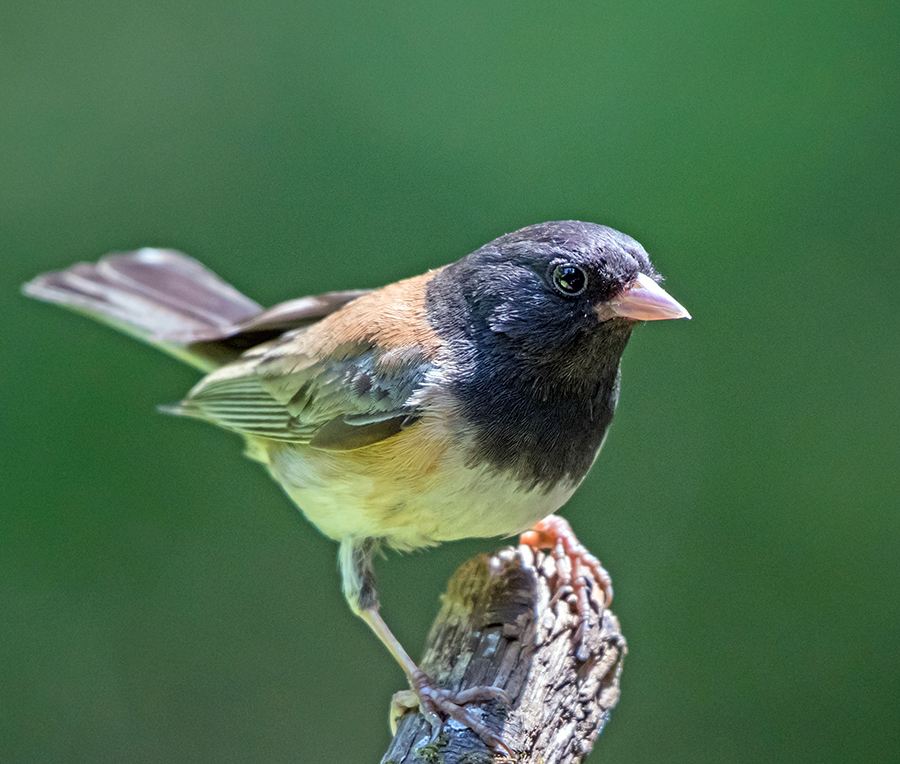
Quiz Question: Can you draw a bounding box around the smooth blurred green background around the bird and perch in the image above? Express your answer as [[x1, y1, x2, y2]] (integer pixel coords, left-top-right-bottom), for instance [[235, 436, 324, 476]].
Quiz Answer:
[[0, 0, 900, 764]]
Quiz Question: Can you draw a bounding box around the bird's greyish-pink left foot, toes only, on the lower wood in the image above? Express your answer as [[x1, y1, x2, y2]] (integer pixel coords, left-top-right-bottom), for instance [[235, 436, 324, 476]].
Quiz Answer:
[[390, 670, 515, 760]]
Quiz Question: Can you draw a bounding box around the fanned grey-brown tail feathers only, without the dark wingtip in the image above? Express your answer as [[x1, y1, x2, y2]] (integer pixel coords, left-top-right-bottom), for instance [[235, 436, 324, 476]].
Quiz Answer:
[[22, 249, 262, 371]]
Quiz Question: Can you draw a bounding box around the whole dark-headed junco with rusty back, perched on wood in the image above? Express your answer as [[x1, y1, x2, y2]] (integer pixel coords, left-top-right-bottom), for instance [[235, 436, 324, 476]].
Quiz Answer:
[[24, 221, 689, 746]]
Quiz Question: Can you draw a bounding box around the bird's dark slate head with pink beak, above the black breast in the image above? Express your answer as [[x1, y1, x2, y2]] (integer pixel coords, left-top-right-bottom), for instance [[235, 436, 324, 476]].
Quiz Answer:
[[435, 221, 690, 388]]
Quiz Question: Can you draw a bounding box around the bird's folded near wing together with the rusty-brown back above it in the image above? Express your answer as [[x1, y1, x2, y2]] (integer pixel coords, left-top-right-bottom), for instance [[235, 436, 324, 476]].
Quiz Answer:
[[165, 271, 443, 450]]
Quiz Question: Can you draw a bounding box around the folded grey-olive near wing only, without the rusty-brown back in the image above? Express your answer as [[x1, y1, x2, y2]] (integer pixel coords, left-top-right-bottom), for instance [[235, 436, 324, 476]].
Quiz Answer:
[[168, 330, 432, 450]]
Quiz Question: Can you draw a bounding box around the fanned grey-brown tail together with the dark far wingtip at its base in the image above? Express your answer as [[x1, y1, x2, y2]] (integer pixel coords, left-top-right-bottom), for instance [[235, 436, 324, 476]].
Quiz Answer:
[[22, 249, 368, 371]]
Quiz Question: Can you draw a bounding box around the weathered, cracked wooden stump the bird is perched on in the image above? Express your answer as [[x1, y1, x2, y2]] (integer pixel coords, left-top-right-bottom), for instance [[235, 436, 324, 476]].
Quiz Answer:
[[382, 546, 627, 764]]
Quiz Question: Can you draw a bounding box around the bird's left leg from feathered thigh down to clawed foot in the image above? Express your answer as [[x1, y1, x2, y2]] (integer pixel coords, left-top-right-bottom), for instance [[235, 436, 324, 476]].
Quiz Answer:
[[340, 539, 513, 758]]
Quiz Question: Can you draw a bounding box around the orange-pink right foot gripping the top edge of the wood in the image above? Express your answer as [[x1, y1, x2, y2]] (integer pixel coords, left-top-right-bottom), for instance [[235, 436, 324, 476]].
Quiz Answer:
[[519, 515, 613, 660]]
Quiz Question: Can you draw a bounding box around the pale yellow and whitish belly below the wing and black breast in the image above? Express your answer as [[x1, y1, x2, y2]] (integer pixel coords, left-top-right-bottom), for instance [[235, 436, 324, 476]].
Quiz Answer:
[[266, 420, 577, 548]]
